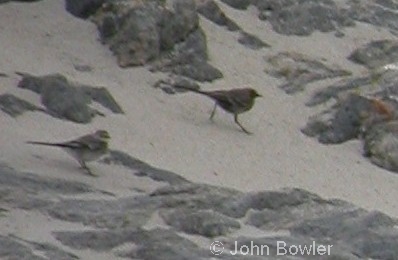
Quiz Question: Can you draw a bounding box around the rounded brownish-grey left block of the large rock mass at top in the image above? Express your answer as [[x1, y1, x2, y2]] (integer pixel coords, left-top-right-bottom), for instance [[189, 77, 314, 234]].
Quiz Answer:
[[94, 1, 162, 67]]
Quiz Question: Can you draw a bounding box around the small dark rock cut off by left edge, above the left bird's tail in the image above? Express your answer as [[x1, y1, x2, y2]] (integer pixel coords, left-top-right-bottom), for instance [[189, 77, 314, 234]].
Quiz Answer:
[[0, 94, 43, 117]]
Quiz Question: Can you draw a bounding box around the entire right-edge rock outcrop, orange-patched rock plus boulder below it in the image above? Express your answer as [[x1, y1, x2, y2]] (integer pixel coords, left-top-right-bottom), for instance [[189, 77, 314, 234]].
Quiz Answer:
[[302, 67, 398, 172]]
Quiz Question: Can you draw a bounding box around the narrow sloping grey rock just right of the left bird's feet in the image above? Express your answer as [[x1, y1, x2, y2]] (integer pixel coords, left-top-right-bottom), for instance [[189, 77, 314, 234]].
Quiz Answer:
[[101, 150, 188, 184]]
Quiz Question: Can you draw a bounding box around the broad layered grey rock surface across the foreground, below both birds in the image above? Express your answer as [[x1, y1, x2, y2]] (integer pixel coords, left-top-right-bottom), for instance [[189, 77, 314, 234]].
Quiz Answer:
[[0, 151, 398, 260]]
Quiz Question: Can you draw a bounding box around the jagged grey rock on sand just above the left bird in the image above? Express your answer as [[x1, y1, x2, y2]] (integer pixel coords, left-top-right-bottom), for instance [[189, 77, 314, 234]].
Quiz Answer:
[[18, 74, 123, 123]]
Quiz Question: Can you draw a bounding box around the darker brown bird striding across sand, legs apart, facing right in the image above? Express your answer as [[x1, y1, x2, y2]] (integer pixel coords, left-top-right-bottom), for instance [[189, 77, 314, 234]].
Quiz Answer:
[[174, 86, 262, 135]]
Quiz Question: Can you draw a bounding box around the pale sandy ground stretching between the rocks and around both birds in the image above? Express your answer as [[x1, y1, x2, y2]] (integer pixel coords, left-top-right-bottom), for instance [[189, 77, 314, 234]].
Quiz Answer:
[[0, 0, 398, 242]]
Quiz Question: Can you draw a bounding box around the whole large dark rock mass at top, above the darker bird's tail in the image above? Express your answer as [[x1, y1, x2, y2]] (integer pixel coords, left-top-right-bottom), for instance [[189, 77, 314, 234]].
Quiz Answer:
[[93, 0, 222, 81]]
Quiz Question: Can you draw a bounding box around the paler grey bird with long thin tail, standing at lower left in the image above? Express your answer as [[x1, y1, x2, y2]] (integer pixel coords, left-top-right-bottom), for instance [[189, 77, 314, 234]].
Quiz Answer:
[[26, 130, 110, 176]]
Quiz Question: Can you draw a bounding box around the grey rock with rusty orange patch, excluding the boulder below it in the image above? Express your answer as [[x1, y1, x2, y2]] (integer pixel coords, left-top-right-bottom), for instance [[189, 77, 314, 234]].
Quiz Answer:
[[302, 69, 398, 143]]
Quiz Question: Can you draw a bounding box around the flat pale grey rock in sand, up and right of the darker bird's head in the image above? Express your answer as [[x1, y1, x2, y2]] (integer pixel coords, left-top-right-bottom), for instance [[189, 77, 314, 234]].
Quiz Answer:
[[265, 52, 351, 94]]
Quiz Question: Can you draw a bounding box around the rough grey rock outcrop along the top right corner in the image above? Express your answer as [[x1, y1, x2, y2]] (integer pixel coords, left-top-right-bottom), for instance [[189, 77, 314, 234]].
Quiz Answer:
[[222, 0, 398, 36]]
